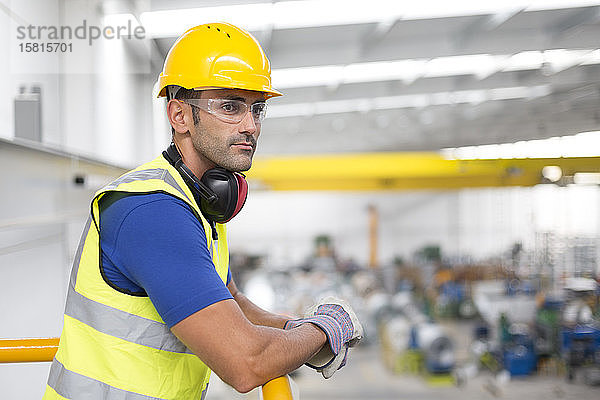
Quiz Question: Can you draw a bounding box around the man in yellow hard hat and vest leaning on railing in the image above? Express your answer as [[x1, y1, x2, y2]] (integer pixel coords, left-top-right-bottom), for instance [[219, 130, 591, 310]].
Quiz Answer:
[[44, 24, 362, 400]]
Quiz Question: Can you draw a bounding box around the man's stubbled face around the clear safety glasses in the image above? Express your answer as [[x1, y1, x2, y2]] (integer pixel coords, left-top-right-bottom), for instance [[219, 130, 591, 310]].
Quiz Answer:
[[189, 89, 264, 171]]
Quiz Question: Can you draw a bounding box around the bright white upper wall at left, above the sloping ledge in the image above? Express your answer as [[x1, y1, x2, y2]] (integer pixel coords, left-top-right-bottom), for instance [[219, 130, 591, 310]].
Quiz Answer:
[[0, 0, 161, 166]]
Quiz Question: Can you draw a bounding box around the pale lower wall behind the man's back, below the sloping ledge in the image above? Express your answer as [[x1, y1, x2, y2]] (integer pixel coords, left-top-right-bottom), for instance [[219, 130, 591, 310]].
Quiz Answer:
[[0, 141, 121, 400]]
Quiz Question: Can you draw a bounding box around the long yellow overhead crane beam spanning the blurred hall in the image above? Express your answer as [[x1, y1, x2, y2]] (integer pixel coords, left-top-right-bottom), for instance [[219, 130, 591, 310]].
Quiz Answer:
[[247, 152, 600, 191]]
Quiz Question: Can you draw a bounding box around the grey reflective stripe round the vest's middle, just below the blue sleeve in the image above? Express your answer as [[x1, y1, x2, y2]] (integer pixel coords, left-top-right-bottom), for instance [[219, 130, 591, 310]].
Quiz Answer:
[[65, 285, 191, 354]]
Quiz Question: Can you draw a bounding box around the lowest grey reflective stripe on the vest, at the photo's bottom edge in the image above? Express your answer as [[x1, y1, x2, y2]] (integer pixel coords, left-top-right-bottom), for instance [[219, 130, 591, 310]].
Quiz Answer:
[[48, 358, 169, 400]]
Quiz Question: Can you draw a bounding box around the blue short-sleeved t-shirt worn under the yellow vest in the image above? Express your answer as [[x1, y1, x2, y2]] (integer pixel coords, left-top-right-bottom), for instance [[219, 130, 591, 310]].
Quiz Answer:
[[100, 193, 232, 327]]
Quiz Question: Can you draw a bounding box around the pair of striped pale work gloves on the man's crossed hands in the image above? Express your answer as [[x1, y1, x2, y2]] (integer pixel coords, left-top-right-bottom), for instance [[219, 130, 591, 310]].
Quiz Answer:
[[284, 297, 363, 379]]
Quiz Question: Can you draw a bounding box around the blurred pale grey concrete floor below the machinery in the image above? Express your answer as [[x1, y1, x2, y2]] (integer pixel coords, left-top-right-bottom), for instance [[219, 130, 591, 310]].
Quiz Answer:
[[207, 323, 600, 400]]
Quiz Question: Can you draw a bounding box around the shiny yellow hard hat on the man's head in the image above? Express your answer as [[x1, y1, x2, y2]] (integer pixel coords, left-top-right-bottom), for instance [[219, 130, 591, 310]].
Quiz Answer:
[[158, 23, 282, 98]]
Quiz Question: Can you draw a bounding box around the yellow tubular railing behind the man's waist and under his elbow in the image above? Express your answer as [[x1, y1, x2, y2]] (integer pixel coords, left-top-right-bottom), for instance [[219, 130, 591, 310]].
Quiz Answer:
[[0, 338, 292, 400]]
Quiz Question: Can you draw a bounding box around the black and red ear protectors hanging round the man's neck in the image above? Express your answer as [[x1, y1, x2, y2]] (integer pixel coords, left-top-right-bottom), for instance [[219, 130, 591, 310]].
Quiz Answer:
[[163, 143, 248, 223]]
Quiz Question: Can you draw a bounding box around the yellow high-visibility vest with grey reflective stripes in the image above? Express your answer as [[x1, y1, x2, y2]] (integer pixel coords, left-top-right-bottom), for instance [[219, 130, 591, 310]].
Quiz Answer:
[[43, 156, 229, 400]]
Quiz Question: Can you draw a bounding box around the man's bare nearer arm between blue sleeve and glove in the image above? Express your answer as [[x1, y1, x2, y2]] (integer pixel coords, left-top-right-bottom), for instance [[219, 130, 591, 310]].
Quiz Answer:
[[171, 300, 327, 392]]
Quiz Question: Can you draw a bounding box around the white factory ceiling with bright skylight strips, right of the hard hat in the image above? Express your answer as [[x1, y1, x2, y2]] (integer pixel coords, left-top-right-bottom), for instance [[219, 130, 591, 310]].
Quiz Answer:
[[142, 0, 600, 154]]
